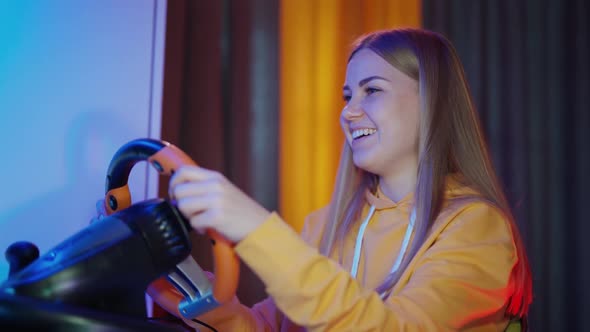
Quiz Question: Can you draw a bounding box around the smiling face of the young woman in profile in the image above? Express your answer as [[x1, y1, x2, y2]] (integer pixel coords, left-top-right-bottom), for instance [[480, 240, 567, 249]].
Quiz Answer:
[[340, 49, 420, 177]]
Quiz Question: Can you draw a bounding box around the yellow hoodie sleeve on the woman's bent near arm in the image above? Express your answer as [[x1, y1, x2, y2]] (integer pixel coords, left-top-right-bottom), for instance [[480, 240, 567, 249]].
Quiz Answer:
[[236, 203, 517, 331]]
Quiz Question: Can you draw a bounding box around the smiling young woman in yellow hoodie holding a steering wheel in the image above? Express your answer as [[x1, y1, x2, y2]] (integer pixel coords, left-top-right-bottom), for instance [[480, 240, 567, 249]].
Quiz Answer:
[[170, 29, 532, 331]]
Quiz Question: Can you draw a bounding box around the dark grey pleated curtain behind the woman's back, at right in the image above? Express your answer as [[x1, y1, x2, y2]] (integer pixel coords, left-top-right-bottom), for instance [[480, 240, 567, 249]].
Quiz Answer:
[[423, 0, 590, 331]]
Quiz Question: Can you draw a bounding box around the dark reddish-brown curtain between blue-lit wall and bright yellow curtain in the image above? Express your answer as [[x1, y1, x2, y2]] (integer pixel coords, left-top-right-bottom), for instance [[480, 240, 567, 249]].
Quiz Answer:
[[160, 0, 279, 305]]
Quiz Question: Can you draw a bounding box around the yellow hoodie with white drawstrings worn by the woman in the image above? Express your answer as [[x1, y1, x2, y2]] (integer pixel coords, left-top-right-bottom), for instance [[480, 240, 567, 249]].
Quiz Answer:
[[199, 180, 518, 332]]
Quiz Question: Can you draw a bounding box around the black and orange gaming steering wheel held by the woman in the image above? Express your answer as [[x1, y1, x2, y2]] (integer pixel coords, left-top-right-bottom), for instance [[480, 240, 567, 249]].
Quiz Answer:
[[104, 138, 240, 319]]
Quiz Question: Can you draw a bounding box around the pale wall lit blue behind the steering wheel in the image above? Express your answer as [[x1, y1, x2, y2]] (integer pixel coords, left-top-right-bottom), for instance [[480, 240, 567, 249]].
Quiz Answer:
[[0, 0, 166, 281]]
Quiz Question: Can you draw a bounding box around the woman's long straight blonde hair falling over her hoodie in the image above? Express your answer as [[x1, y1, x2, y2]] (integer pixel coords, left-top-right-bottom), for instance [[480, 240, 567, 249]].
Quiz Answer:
[[320, 29, 532, 317]]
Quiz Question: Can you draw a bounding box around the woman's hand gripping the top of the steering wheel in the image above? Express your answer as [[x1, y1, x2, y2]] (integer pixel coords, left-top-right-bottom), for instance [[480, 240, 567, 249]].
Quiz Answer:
[[169, 166, 270, 243]]
